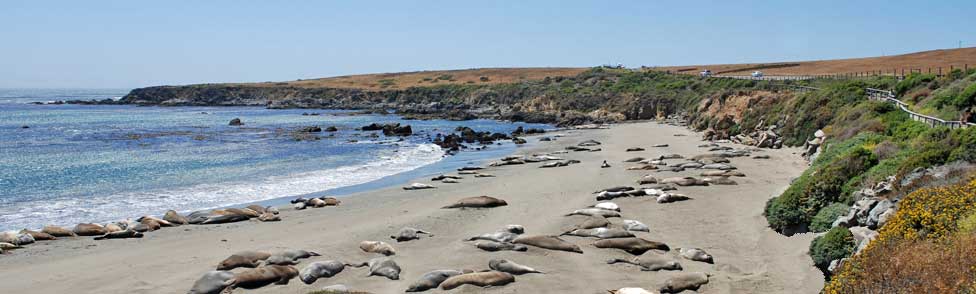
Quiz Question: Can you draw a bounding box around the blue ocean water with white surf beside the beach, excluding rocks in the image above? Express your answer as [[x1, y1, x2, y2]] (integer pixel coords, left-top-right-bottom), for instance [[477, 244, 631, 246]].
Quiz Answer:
[[0, 89, 549, 230]]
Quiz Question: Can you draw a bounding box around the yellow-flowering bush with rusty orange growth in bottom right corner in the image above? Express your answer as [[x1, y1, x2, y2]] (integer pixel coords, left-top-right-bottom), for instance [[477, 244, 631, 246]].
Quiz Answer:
[[824, 180, 976, 293]]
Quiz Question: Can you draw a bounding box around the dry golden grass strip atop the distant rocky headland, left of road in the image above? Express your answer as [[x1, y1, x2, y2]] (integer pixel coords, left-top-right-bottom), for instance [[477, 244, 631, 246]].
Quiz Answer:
[[239, 67, 587, 90]]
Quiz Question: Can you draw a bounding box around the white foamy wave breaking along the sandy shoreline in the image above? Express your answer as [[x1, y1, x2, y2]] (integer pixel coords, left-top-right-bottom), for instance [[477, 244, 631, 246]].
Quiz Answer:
[[0, 144, 444, 229]]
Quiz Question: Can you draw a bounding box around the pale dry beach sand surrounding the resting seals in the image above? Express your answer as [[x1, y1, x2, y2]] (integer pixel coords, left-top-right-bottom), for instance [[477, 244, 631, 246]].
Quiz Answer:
[[0, 122, 823, 293]]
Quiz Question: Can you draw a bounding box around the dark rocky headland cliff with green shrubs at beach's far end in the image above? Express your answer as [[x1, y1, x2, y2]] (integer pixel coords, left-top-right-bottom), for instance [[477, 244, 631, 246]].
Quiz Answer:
[[119, 68, 768, 125]]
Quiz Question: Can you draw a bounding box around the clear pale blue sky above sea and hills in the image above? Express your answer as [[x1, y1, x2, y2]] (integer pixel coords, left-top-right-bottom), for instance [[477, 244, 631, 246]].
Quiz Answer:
[[0, 0, 976, 88]]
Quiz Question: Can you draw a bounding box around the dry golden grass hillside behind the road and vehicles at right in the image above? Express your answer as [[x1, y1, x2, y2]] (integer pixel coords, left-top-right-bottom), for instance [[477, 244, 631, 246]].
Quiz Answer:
[[656, 47, 976, 76]]
